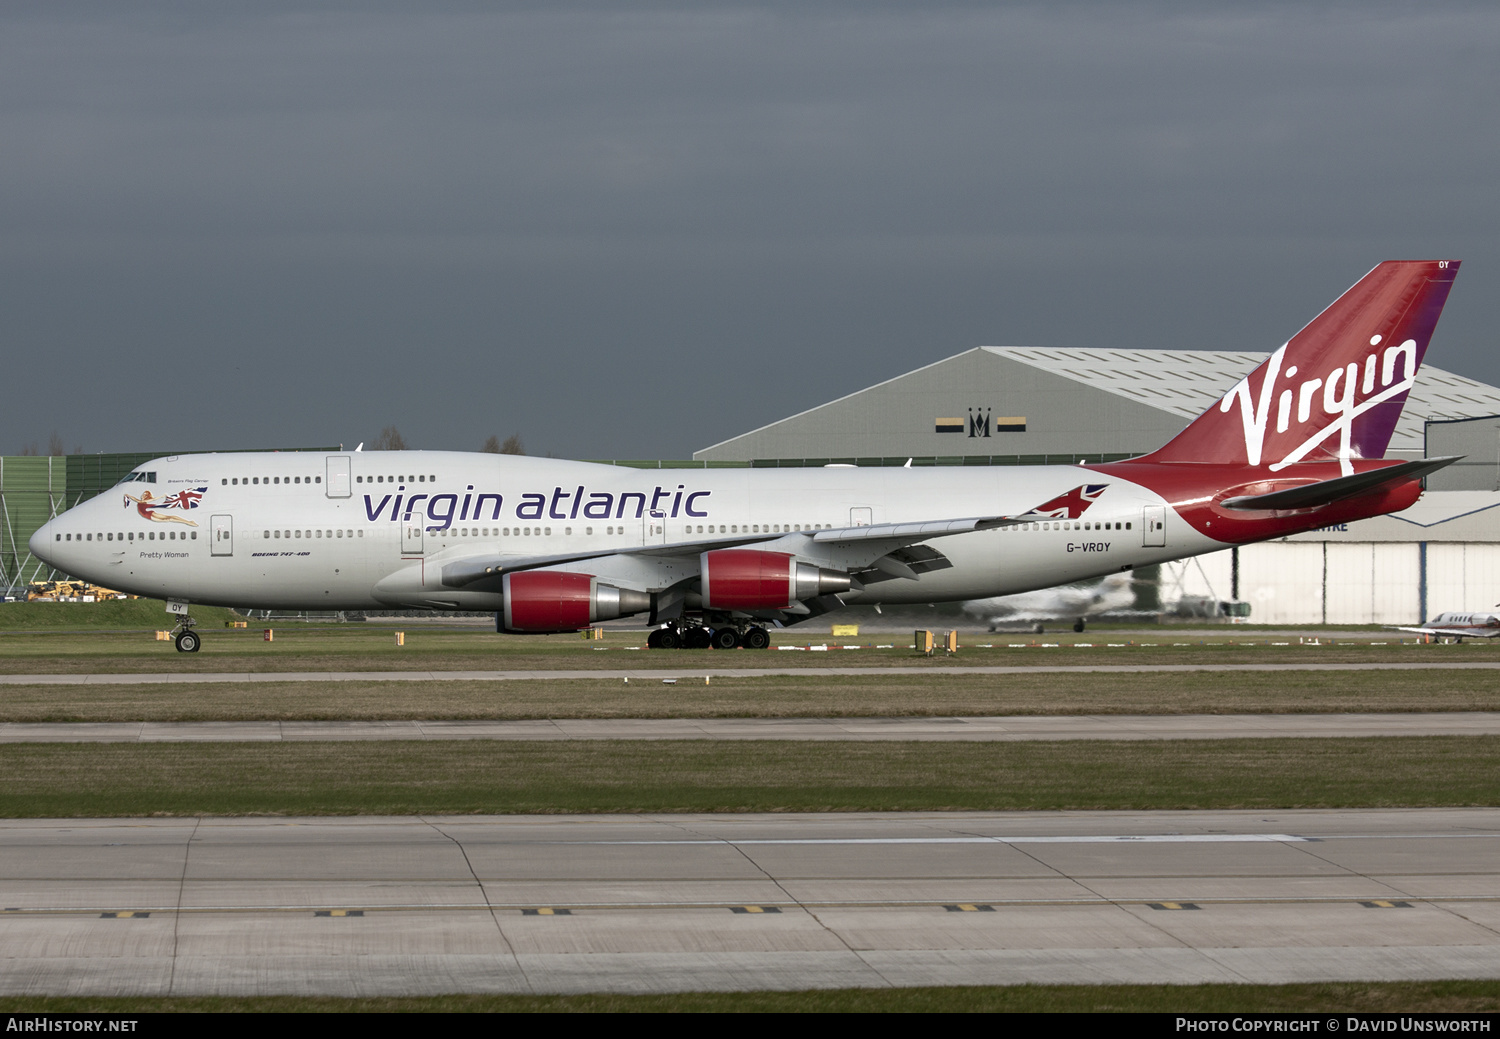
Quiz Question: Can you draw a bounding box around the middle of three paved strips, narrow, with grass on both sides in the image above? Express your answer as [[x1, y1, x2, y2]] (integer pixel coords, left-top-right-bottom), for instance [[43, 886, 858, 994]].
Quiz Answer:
[[0, 711, 1500, 744]]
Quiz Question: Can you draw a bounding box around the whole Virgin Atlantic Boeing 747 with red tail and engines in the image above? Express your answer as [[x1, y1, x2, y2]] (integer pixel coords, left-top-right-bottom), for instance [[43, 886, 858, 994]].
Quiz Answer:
[[30, 261, 1458, 652]]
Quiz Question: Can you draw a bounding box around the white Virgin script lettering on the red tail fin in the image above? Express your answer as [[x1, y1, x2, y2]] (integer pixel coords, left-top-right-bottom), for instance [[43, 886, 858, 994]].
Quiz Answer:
[[1220, 336, 1418, 475]]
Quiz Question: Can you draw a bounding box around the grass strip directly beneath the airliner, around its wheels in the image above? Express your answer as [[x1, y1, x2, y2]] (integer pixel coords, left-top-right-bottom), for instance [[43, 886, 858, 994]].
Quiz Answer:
[[0, 614, 1500, 675]]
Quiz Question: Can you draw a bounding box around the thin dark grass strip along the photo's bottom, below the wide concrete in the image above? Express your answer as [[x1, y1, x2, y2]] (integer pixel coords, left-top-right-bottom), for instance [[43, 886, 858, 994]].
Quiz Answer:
[[0, 981, 1500, 1014]]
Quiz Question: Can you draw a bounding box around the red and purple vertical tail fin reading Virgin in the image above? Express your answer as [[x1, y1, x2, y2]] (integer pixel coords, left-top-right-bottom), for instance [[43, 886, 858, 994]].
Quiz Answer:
[[1146, 259, 1458, 472]]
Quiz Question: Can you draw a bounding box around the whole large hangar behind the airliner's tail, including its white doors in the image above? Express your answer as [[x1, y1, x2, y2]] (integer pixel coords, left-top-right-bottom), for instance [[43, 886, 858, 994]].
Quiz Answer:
[[693, 346, 1500, 624]]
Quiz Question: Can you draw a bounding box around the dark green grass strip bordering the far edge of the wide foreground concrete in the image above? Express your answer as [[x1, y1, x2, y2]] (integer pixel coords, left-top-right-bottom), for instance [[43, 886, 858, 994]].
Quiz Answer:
[[0, 736, 1500, 819]]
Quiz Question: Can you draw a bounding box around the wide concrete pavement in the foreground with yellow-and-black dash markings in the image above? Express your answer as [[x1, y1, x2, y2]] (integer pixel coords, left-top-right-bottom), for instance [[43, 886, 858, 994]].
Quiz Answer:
[[0, 810, 1500, 996]]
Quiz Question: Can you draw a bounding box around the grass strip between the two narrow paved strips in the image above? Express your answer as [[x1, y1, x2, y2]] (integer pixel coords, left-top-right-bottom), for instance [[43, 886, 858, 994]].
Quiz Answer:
[[0, 670, 1500, 721]]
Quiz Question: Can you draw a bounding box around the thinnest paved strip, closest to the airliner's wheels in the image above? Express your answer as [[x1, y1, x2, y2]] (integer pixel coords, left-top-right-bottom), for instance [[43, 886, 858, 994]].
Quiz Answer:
[[0, 661, 1500, 685]]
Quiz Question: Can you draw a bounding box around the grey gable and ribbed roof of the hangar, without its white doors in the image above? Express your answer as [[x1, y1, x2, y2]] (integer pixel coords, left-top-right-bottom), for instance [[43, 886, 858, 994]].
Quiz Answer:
[[693, 346, 1500, 465]]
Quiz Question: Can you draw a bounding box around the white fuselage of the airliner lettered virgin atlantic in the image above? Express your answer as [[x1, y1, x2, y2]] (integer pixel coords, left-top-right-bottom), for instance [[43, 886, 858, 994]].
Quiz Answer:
[[32, 451, 1223, 610]]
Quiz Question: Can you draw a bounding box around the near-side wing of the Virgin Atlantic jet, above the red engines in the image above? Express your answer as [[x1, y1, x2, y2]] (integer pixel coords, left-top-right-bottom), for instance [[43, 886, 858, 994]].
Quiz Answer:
[[443, 516, 1029, 588]]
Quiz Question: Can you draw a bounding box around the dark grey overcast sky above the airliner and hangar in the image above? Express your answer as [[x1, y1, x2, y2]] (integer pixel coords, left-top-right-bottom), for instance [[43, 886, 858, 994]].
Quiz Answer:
[[0, 0, 1500, 457]]
